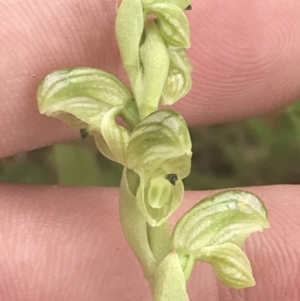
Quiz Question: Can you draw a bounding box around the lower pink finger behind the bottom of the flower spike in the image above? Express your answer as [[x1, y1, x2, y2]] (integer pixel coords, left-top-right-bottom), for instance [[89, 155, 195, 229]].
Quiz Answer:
[[0, 184, 300, 301]]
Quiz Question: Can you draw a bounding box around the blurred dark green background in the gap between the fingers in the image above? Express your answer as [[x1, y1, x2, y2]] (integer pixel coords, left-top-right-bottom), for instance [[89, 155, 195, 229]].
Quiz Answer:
[[0, 101, 300, 189]]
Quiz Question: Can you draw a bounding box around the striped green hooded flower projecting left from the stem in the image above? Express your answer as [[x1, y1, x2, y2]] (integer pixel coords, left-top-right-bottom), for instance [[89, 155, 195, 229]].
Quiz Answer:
[[37, 67, 133, 164]]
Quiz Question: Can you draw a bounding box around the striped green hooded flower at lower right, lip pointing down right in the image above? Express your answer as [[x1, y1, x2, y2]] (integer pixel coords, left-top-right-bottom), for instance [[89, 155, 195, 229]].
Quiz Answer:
[[172, 190, 269, 288]]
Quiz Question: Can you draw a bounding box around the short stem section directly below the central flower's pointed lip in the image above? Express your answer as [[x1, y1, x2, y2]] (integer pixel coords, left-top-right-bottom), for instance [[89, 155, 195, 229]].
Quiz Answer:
[[147, 221, 170, 265]]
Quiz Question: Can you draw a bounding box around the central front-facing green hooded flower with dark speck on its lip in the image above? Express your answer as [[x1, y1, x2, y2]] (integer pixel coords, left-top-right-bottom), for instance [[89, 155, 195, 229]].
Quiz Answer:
[[126, 110, 192, 226]]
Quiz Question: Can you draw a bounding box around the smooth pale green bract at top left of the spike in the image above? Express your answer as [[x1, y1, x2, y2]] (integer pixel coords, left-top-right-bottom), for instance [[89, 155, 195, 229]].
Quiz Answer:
[[116, 0, 144, 87]]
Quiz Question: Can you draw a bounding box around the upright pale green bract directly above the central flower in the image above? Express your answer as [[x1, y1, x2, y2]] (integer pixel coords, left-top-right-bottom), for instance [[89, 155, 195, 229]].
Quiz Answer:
[[133, 20, 169, 119]]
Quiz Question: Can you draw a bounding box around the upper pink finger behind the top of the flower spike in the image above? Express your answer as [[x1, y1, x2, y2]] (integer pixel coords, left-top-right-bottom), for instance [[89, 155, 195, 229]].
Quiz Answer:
[[0, 0, 300, 157]]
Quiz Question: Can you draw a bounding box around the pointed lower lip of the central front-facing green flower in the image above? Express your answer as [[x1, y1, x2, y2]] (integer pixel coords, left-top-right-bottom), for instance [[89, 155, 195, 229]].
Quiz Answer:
[[136, 173, 184, 227]]
